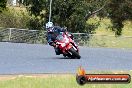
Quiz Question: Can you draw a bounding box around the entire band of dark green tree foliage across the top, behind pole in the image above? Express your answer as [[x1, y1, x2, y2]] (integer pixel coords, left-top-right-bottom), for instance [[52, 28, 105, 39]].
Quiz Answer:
[[16, 0, 132, 35]]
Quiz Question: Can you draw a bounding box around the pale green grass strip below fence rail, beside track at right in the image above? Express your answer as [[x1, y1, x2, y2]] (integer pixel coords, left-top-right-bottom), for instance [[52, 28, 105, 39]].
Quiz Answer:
[[85, 35, 132, 48]]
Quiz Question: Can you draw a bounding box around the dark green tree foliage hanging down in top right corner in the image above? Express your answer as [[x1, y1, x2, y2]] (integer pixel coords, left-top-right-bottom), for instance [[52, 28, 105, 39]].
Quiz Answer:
[[99, 0, 132, 36]]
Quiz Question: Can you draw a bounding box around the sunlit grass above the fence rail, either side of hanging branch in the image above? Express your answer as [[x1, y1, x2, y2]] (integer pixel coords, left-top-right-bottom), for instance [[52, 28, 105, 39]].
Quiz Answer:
[[88, 17, 132, 36]]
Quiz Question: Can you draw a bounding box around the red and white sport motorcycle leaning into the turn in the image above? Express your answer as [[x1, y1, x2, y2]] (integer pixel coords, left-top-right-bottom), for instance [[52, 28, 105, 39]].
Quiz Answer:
[[55, 32, 81, 59]]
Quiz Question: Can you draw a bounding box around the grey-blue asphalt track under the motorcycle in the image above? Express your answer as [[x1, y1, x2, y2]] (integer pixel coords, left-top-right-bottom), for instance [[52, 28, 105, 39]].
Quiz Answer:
[[0, 42, 132, 74]]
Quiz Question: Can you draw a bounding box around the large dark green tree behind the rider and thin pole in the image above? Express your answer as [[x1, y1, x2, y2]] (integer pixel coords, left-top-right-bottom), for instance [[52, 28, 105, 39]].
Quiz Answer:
[[24, 0, 104, 33]]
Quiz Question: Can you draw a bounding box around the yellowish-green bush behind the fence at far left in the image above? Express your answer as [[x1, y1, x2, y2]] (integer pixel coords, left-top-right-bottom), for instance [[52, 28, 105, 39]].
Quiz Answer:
[[0, 8, 30, 28]]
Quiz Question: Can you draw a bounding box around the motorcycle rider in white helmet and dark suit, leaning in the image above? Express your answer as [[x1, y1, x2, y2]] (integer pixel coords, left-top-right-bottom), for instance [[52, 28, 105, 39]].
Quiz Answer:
[[46, 22, 77, 55]]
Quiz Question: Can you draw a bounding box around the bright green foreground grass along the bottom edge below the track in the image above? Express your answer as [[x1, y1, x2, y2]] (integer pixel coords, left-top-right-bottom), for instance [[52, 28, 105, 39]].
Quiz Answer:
[[0, 72, 132, 88]]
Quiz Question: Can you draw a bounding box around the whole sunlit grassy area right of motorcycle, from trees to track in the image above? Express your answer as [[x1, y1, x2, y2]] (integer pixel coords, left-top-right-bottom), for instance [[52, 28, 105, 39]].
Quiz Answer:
[[85, 16, 132, 48]]
